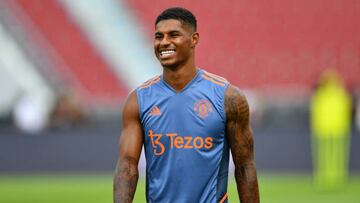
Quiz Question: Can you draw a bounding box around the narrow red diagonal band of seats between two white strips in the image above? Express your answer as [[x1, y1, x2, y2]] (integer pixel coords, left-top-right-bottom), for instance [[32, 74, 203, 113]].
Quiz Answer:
[[8, 0, 128, 103]]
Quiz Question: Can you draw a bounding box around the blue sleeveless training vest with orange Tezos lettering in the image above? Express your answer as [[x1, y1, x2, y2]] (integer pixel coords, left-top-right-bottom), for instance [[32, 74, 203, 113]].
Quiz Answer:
[[136, 69, 229, 203]]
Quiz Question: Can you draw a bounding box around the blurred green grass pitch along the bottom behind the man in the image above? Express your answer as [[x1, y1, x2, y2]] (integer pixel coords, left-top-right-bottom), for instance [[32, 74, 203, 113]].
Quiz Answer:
[[0, 174, 360, 203]]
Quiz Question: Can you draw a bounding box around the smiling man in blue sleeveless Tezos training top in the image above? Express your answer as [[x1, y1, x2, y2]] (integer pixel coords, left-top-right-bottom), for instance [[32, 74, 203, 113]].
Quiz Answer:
[[114, 8, 259, 203]]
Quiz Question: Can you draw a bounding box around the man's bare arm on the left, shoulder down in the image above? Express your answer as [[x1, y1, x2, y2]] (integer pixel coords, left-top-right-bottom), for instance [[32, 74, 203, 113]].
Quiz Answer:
[[114, 92, 143, 203]]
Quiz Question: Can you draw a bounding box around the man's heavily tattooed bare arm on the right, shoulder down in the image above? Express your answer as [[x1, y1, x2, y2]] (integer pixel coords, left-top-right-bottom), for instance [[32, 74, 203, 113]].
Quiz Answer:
[[225, 86, 260, 203]]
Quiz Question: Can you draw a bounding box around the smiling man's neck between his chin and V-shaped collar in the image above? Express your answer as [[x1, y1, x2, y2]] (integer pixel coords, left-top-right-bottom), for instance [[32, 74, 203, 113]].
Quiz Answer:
[[163, 60, 197, 92]]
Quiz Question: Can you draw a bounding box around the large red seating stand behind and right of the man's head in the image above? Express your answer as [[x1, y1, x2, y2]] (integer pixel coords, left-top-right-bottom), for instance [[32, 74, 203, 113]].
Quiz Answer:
[[126, 0, 360, 90]]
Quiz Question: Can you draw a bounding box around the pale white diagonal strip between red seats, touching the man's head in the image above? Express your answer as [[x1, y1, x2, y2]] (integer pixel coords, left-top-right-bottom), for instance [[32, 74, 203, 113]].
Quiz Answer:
[[60, 0, 161, 89]]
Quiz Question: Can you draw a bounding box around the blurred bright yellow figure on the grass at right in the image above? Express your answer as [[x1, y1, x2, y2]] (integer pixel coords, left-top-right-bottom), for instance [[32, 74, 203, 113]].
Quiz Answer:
[[310, 70, 351, 189]]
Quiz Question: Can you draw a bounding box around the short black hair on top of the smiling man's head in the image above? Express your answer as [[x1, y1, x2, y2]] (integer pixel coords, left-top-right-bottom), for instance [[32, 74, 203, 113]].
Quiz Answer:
[[155, 7, 197, 31]]
